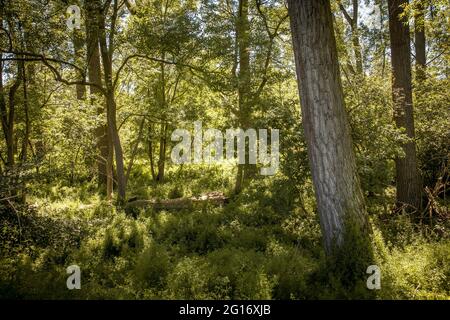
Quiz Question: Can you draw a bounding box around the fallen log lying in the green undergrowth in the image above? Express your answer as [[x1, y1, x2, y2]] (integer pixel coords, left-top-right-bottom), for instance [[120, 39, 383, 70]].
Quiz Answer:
[[126, 191, 229, 210]]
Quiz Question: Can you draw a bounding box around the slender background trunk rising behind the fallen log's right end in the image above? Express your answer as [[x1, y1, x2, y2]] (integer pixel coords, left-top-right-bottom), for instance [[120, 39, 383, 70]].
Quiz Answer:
[[235, 0, 250, 193]]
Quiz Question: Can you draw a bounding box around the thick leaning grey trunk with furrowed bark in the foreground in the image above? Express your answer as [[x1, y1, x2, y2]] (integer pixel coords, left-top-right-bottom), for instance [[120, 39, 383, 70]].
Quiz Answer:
[[288, 0, 370, 255]]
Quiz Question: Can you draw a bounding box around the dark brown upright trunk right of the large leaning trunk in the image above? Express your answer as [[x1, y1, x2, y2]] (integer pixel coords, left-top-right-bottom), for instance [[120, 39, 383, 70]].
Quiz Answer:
[[388, 0, 421, 211]]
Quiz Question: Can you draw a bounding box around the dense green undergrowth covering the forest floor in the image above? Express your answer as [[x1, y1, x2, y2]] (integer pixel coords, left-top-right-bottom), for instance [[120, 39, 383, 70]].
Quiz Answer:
[[0, 168, 450, 299]]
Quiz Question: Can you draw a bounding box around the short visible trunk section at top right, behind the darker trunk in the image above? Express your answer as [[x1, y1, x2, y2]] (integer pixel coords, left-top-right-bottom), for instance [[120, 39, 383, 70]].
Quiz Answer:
[[414, 1, 427, 81]]
